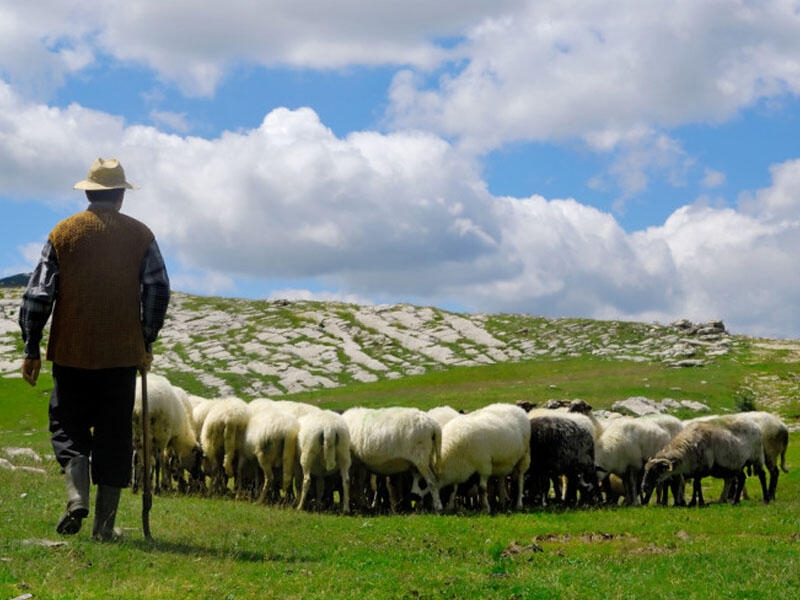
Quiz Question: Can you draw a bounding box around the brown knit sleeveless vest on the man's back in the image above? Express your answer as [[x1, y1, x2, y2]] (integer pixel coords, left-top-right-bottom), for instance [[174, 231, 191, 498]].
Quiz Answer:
[[47, 207, 153, 369]]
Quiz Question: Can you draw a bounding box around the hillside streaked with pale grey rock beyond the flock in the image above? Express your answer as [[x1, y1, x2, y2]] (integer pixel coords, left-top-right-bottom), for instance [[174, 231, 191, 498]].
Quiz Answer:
[[0, 287, 779, 398]]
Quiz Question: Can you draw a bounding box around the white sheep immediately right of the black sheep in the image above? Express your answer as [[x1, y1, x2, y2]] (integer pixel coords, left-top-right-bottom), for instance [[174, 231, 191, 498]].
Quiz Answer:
[[594, 418, 672, 506]]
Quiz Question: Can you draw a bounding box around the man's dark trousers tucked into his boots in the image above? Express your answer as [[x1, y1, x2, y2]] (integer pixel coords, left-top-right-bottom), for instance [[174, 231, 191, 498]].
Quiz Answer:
[[49, 364, 136, 487]]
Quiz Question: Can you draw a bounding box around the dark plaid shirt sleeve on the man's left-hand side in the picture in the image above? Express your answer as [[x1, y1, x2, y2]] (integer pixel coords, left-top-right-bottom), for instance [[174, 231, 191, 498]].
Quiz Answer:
[[19, 240, 58, 359]]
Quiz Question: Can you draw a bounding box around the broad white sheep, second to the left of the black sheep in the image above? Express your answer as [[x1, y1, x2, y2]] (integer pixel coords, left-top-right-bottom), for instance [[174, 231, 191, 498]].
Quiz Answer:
[[342, 406, 442, 512]]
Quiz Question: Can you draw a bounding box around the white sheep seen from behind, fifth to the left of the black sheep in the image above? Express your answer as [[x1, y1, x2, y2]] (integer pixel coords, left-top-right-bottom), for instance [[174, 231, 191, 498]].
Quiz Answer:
[[200, 396, 250, 493]]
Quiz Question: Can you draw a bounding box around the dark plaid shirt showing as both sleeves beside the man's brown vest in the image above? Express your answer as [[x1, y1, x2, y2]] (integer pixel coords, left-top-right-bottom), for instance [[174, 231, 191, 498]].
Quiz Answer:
[[19, 240, 169, 359]]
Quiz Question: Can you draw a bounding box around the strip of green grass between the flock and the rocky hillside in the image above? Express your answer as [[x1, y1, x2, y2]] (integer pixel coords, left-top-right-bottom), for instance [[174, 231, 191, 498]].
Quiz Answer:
[[293, 356, 800, 417]]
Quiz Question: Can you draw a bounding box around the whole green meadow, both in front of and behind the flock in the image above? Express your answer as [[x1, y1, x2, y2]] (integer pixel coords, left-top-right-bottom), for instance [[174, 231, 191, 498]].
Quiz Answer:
[[0, 352, 800, 599]]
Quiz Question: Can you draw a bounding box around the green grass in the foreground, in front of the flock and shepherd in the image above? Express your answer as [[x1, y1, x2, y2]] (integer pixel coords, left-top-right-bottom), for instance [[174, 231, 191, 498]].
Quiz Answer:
[[0, 454, 800, 598]]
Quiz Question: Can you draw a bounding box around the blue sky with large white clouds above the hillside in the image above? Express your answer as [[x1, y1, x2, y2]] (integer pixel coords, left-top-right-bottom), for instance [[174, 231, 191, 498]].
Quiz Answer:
[[0, 0, 800, 338]]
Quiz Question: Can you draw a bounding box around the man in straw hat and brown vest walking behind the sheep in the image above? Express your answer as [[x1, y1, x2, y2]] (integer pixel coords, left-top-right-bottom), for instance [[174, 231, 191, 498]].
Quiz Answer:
[[19, 158, 170, 541]]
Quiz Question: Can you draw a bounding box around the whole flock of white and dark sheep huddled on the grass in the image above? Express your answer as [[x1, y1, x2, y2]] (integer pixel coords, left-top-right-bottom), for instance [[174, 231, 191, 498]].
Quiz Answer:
[[133, 374, 789, 513]]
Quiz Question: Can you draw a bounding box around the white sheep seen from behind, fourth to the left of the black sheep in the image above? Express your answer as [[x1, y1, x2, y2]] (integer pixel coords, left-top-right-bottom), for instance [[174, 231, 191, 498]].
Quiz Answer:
[[238, 400, 300, 503]]
